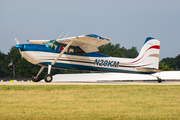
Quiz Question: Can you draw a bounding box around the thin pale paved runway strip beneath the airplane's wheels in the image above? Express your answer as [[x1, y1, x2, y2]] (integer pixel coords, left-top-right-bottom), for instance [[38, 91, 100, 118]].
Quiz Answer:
[[0, 81, 180, 85]]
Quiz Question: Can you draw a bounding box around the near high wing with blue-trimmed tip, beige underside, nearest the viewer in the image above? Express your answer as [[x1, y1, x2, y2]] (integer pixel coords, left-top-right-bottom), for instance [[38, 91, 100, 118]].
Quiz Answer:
[[56, 34, 110, 53]]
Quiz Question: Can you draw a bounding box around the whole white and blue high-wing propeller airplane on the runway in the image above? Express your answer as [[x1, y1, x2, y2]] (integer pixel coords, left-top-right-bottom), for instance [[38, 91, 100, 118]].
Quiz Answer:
[[15, 34, 161, 82]]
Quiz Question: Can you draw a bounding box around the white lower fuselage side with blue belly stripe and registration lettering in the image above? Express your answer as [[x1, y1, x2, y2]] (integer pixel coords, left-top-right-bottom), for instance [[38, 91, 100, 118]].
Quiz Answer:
[[21, 51, 153, 73]]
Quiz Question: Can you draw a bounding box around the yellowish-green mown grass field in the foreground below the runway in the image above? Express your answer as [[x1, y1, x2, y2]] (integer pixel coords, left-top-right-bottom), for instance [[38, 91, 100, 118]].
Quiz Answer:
[[0, 85, 180, 120]]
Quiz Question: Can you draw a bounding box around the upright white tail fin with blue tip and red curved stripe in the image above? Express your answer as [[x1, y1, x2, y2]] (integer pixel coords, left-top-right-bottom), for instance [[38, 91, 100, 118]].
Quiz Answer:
[[131, 37, 160, 69]]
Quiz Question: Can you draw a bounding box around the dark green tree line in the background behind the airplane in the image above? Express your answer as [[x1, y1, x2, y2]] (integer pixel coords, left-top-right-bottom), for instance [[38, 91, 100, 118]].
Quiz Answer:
[[0, 42, 180, 78]]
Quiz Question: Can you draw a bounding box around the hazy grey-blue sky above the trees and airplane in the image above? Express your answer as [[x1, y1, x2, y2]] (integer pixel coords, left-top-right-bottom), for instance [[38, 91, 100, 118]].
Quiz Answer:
[[0, 0, 180, 60]]
